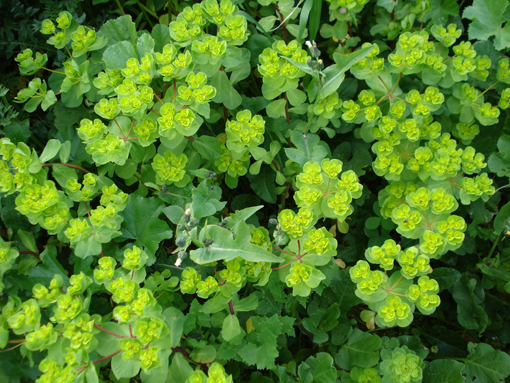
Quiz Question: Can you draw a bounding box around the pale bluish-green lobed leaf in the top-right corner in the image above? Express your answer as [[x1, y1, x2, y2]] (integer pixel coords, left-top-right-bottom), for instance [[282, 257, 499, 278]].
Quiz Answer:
[[462, 0, 510, 51]]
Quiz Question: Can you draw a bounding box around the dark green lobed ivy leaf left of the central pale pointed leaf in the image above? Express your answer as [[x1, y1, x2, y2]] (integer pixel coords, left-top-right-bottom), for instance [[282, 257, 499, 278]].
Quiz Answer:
[[119, 195, 172, 266]]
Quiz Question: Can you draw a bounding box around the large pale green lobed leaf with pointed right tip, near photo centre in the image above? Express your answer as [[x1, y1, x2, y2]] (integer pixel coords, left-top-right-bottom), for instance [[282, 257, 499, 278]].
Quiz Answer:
[[190, 222, 282, 265]]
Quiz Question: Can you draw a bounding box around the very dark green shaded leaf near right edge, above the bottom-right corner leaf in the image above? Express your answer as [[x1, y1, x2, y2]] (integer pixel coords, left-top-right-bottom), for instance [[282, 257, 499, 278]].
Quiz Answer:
[[452, 274, 489, 332]]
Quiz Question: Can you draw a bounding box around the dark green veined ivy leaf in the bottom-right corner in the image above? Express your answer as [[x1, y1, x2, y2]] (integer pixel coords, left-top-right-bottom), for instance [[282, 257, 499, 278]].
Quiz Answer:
[[462, 343, 510, 383]]
